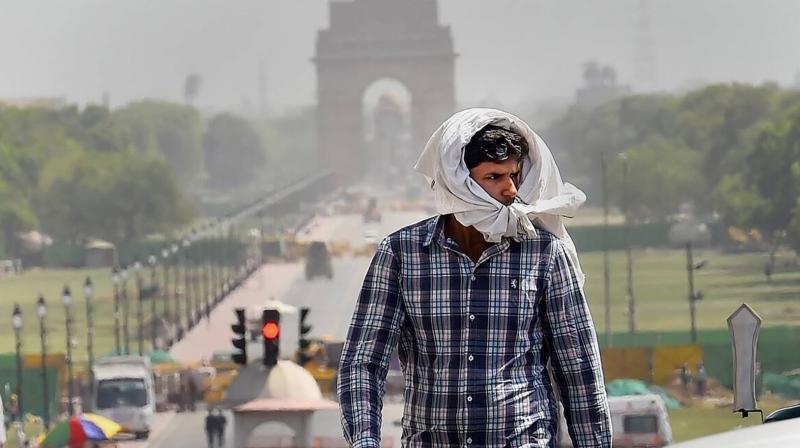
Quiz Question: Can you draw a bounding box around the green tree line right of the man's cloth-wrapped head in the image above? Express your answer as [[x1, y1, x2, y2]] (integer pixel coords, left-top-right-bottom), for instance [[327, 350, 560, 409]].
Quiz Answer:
[[544, 83, 800, 250]]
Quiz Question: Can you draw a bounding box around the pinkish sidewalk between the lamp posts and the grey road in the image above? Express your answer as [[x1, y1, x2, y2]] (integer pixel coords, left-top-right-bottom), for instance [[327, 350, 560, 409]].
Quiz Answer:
[[170, 263, 303, 363]]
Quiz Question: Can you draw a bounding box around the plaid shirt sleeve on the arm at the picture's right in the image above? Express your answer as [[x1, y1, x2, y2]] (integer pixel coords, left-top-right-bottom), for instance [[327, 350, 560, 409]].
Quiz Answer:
[[544, 240, 612, 448]]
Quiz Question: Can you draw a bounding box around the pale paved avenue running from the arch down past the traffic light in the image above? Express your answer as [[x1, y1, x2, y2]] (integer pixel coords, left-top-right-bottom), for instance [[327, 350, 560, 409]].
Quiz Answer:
[[122, 212, 424, 448]]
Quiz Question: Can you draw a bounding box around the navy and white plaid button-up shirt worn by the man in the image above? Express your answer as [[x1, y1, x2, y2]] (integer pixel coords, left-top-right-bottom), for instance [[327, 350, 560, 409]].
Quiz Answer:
[[338, 216, 611, 448]]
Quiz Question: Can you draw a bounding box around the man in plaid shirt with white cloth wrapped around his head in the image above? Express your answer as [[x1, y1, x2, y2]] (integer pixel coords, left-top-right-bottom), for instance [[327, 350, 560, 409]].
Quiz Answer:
[[338, 109, 611, 448]]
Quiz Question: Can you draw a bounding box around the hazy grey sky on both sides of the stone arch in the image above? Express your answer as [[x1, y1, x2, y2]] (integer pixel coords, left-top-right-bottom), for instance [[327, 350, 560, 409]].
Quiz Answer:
[[0, 0, 800, 111]]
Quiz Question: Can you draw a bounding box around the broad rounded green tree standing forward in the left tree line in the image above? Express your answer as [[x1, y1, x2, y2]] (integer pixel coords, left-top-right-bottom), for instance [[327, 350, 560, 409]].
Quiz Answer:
[[39, 152, 193, 243]]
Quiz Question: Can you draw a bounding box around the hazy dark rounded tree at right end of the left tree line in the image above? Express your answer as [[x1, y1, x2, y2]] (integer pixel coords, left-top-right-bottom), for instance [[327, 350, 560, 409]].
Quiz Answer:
[[204, 113, 266, 188]]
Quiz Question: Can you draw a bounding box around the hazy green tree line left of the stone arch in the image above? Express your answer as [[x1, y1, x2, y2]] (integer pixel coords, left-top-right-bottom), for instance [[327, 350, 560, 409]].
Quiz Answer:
[[0, 100, 293, 256]]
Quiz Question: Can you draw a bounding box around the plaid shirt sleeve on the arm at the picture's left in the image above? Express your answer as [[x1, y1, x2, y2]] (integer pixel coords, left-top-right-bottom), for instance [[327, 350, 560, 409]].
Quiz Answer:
[[337, 238, 405, 448]]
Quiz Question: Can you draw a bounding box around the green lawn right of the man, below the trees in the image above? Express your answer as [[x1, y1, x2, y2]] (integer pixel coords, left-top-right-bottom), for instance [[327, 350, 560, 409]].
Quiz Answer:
[[581, 249, 800, 333]]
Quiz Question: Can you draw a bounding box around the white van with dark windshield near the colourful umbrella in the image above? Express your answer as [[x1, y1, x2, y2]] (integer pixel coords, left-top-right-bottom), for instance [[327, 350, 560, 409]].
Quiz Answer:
[[92, 356, 156, 439]]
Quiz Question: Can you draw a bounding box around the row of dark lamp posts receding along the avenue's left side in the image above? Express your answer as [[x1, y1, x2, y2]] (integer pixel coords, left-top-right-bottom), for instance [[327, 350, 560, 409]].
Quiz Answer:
[[6, 222, 253, 427]]
